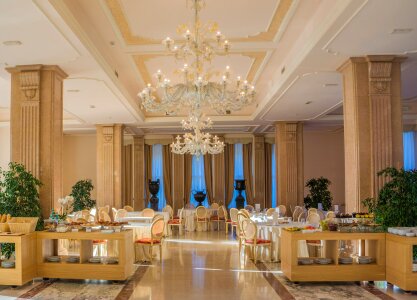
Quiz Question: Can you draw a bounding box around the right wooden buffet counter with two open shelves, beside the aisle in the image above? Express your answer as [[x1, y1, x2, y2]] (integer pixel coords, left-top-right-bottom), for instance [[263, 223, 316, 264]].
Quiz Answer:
[[281, 230, 385, 281]]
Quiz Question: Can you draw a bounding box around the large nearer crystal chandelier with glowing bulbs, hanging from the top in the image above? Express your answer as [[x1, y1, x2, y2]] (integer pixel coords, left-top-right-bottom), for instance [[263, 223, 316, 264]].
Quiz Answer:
[[138, 0, 255, 115]]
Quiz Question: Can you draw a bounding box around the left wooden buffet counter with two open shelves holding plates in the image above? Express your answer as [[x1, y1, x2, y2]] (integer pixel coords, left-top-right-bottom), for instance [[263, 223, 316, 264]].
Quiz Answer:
[[36, 230, 134, 280]]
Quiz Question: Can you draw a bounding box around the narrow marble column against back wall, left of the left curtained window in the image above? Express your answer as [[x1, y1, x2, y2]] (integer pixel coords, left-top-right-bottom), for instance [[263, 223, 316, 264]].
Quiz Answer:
[[133, 136, 145, 211]]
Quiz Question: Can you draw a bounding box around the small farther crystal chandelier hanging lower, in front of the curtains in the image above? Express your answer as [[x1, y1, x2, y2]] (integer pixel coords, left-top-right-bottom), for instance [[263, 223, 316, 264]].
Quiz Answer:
[[171, 114, 224, 157]]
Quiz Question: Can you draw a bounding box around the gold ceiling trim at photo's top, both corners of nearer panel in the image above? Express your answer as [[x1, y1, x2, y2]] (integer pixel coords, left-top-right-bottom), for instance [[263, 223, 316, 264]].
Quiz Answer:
[[106, 0, 293, 46]]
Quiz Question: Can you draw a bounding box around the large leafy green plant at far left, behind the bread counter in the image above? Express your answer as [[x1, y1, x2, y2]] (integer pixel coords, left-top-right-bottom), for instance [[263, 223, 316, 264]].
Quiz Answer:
[[0, 162, 43, 259]]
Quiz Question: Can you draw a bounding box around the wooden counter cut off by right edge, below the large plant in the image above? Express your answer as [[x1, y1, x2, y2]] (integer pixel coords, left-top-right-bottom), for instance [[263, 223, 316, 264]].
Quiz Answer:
[[386, 233, 417, 291]]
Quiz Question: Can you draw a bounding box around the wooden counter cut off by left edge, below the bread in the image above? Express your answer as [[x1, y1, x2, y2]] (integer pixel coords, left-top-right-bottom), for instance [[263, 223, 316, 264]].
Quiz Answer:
[[0, 232, 36, 285]]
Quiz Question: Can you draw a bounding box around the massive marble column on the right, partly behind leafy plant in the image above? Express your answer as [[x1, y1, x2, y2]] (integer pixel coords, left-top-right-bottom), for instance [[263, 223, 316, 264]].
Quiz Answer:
[[338, 55, 404, 212]]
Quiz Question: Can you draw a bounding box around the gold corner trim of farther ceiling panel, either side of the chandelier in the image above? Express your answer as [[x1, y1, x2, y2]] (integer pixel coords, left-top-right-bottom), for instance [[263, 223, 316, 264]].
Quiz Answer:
[[133, 51, 266, 84]]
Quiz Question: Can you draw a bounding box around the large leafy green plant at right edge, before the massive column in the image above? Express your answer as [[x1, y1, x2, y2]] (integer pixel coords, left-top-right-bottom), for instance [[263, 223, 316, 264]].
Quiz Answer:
[[362, 168, 417, 260]]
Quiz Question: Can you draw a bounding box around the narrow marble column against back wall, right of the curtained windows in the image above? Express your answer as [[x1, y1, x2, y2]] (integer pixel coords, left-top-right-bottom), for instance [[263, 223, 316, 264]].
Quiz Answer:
[[253, 135, 266, 208]]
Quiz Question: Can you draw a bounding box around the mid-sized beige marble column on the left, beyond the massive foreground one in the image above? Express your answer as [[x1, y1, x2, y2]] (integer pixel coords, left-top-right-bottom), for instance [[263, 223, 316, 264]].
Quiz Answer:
[[97, 124, 124, 208]]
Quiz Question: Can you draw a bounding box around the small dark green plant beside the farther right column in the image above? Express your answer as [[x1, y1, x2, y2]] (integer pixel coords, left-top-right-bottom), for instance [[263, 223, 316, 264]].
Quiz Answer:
[[304, 177, 333, 211]]
